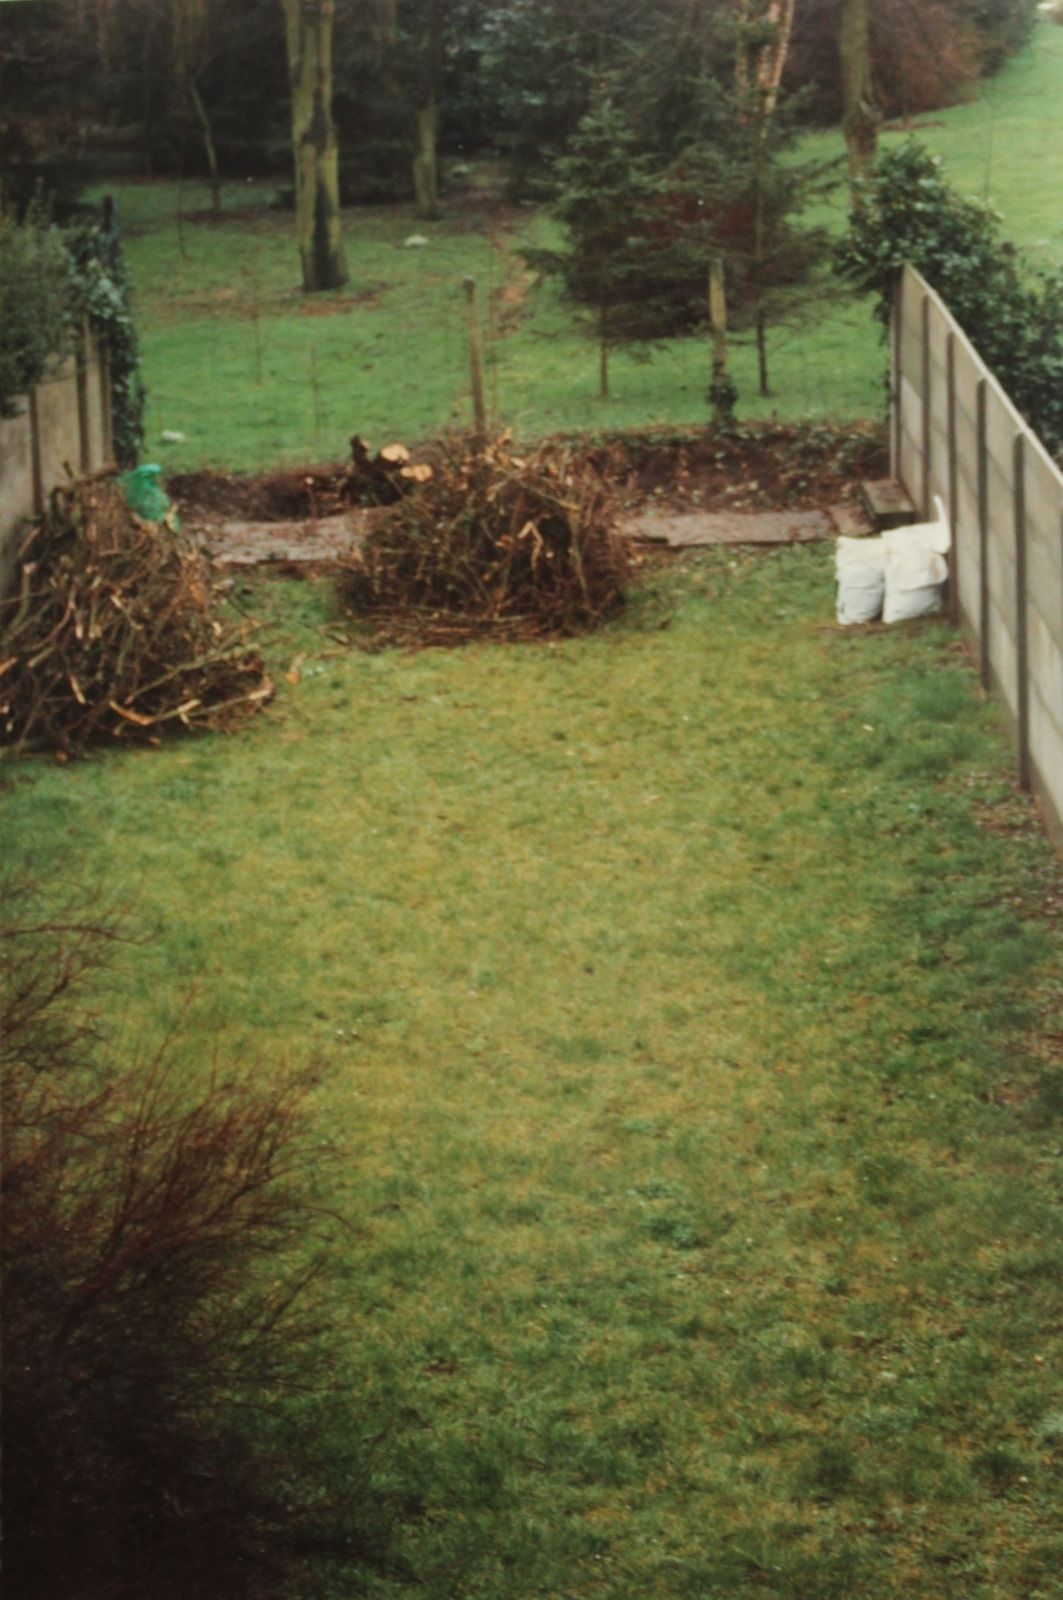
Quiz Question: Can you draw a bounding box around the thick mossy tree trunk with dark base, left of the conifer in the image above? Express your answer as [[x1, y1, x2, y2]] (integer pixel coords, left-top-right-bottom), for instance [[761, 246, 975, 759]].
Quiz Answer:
[[282, 0, 347, 294]]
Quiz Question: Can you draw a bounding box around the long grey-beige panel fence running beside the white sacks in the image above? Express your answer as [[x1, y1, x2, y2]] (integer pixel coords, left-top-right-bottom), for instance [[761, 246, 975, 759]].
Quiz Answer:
[[892, 267, 1063, 845]]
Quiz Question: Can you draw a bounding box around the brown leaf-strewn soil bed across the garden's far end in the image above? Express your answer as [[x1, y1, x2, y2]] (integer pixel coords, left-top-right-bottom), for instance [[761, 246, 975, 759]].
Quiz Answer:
[[166, 424, 887, 522]]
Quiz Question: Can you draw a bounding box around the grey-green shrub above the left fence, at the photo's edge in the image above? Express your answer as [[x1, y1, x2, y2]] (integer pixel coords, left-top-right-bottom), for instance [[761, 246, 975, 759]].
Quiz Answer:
[[0, 211, 74, 416]]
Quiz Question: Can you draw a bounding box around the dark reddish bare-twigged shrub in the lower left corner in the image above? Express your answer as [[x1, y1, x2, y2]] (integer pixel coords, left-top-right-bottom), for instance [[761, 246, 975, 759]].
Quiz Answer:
[[0, 891, 379, 1600]]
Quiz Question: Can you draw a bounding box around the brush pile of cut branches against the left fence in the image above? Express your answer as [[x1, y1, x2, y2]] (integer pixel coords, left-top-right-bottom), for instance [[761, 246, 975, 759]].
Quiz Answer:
[[0, 478, 272, 755]]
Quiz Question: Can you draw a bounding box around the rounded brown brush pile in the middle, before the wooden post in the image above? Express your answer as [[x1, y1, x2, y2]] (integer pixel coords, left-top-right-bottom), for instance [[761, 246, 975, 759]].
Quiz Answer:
[[339, 435, 629, 645]]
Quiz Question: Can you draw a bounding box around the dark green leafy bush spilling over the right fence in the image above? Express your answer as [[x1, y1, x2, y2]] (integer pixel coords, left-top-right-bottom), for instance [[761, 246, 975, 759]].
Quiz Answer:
[[836, 139, 1063, 453]]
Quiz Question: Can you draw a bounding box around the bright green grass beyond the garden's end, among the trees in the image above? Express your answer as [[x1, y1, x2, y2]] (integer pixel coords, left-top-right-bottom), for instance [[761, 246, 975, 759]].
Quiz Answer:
[[122, 24, 1063, 470]]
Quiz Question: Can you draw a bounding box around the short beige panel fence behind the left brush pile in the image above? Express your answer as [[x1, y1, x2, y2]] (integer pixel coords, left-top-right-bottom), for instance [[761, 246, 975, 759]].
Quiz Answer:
[[0, 336, 114, 594]]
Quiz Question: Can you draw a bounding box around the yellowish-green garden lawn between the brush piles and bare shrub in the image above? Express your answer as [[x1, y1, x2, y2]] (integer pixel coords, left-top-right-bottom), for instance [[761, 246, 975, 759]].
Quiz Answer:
[[3, 549, 1063, 1600]]
